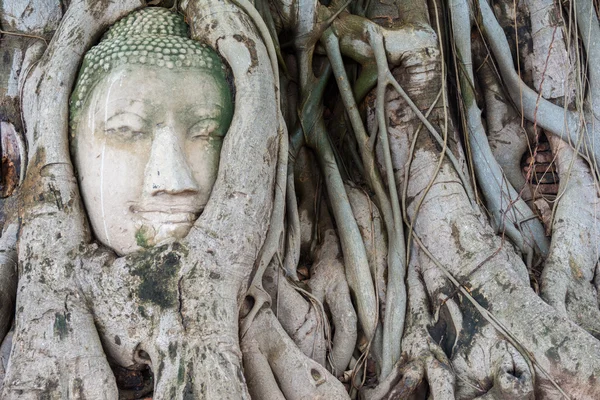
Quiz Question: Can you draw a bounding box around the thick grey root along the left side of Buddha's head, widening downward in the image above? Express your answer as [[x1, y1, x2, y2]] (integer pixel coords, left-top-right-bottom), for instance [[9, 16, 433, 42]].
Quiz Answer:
[[1, 0, 142, 399]]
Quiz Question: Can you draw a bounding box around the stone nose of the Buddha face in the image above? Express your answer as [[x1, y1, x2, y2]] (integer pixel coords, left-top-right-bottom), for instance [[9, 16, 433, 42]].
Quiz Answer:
[[144, 124, 199, 196]]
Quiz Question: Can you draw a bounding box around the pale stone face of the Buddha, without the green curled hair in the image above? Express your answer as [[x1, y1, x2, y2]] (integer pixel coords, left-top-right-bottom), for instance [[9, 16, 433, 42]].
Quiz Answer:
[[74, 65, 232, 255]]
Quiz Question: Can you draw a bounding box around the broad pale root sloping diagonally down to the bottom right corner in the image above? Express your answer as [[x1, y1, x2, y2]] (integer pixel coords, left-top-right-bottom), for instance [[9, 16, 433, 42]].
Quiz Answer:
[[398, 102, 600, 398]]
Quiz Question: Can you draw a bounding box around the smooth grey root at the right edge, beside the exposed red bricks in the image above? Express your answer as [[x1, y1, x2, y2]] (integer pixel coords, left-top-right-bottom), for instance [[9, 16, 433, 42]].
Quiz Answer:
[[541, 136, 600, 338]]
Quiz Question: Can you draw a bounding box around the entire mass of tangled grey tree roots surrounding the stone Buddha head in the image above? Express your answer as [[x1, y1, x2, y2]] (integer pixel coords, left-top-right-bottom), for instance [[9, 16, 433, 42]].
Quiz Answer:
[[0, 0, 600, 400]]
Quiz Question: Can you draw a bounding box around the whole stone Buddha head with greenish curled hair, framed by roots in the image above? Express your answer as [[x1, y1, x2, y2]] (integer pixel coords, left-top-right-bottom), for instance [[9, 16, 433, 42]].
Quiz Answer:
[[71, 8, 233, 255]]
